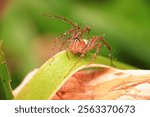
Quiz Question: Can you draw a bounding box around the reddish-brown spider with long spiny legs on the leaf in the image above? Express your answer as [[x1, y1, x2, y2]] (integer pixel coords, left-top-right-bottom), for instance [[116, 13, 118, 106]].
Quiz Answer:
[[41, 13, 112, 65]]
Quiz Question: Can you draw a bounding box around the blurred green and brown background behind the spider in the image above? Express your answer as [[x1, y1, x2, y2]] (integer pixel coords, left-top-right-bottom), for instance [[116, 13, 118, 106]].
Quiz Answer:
[[0, 0, 150, 88]]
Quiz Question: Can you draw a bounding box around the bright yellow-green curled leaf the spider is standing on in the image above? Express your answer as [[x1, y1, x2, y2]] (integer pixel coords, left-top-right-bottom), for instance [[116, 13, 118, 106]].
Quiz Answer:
[[15, 51, 134, 99]]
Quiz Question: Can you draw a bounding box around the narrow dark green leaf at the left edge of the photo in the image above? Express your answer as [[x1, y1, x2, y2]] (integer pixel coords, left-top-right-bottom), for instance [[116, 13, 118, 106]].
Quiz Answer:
[[0, 42, 13, 100]]
